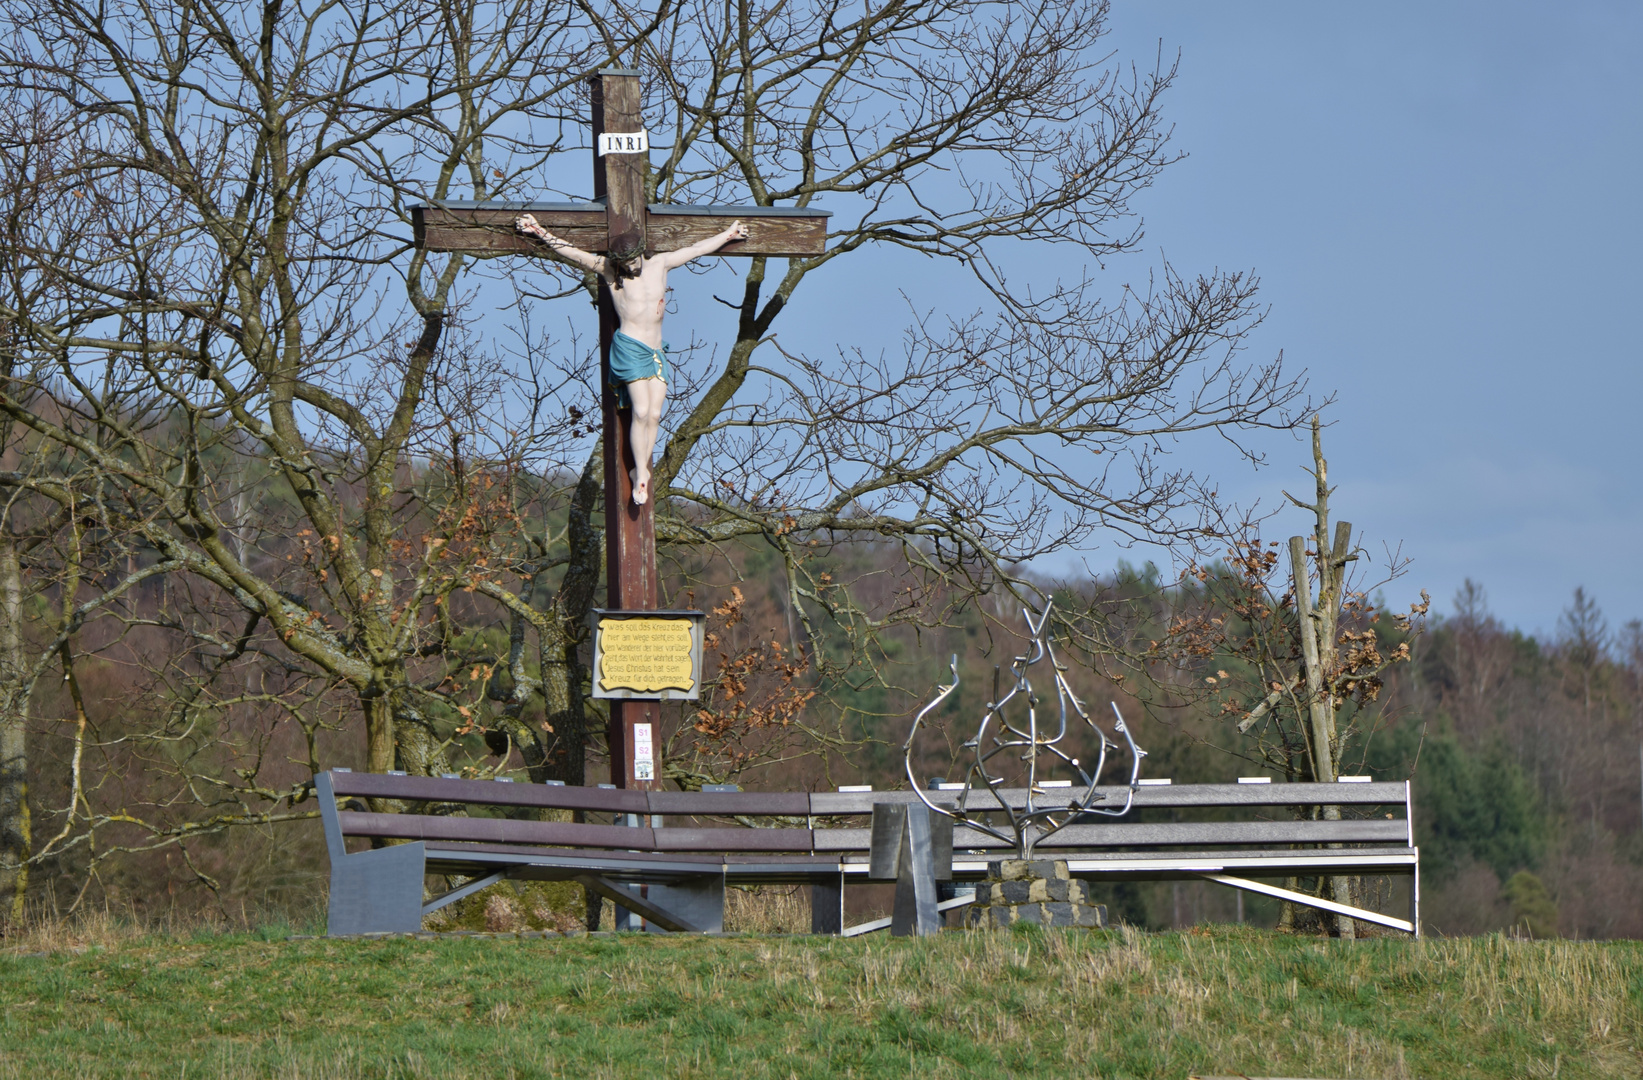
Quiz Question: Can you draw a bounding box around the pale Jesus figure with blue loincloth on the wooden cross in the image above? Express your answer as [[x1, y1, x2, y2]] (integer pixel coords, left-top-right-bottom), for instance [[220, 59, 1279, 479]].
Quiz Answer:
[[514, 214, 748, 503]]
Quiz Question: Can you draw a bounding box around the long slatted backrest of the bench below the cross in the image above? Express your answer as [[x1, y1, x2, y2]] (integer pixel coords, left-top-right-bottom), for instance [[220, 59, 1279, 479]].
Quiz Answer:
[[314, 771, 1415, 856]]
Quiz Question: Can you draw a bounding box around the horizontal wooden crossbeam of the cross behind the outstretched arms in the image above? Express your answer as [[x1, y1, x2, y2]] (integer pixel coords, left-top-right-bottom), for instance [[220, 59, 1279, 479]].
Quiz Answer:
[[411, 202, 831, 258]]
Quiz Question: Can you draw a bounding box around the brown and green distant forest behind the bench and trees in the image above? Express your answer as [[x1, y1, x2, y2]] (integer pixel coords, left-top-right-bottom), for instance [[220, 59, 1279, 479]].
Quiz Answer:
[[6, 499, 1643, 937]]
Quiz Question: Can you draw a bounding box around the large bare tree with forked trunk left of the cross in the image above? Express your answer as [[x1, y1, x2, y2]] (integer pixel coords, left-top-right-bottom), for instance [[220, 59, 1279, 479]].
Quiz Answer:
[[0, 2, 640, 805]]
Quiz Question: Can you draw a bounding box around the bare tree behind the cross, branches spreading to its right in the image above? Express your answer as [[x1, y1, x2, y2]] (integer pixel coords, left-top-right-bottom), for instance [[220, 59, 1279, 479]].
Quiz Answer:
[[522, 0, 1301, 703]]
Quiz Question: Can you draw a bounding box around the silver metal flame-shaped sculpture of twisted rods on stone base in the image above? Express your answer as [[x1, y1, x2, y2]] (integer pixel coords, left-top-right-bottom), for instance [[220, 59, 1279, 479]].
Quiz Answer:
[[902, 605, 1147, 860]]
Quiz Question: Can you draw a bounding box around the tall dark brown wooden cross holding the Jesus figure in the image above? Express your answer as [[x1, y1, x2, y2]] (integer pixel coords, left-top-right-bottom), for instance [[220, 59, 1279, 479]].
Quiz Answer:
[[411, 67, 828, 787]]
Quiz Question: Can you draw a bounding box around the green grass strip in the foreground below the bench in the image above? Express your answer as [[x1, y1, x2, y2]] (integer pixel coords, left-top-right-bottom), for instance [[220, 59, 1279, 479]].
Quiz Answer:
[[0, 929, 1643, 1080]]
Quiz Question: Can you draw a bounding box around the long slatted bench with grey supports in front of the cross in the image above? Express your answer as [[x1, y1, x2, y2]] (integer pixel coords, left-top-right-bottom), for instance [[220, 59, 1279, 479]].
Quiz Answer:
[[314, 769, 1420, 935]]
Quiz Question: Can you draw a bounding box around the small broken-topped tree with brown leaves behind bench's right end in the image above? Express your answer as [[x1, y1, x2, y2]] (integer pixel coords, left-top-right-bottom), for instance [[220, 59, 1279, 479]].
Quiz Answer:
[[1075, 416, 1431, 937]]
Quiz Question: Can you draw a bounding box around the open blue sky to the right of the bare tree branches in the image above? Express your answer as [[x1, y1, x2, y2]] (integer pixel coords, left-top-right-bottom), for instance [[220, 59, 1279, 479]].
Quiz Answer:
[[1107, 0, 1643, 633]]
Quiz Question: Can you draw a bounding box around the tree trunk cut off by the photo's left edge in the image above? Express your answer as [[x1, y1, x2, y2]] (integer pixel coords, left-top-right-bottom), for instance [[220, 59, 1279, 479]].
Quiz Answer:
[[0, 534, 33, 921]]
